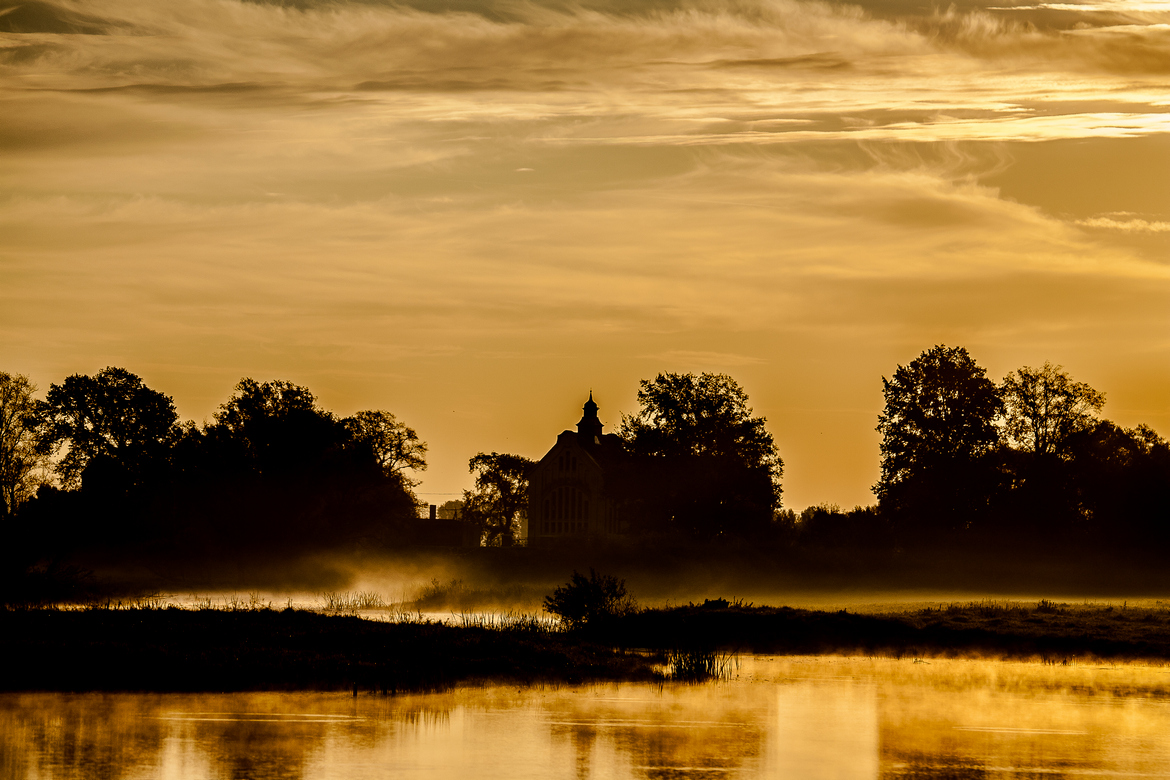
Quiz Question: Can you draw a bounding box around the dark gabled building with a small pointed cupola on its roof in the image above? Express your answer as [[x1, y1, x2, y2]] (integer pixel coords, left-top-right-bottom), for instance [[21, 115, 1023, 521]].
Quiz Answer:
[[525, 393, 624, 546]]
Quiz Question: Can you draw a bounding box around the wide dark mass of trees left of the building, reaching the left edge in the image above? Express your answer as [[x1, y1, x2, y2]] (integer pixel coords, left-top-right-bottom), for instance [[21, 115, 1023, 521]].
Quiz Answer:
[[0, 367, 427, 566]]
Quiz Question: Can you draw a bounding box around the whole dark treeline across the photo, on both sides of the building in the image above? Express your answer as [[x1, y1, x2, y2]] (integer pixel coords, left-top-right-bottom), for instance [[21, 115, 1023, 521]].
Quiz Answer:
[[0, 346, 1170, 603]]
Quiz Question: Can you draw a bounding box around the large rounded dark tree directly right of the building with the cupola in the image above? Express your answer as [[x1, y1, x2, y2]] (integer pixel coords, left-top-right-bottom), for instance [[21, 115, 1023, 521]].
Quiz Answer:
[[619, 373, 784, 539]]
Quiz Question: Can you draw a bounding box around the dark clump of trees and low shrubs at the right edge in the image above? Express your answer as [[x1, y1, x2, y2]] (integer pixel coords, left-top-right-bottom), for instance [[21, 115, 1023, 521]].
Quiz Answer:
[[780, 345, 1170, 554]]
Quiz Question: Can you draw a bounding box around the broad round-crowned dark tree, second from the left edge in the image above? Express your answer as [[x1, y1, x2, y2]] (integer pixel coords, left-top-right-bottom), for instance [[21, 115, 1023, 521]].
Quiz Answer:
[[40, 366, 180, 488]]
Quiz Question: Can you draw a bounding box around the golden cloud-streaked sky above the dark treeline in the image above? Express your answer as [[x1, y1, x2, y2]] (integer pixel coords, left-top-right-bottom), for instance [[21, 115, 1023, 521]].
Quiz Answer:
[[0, 0, 1170, 510]]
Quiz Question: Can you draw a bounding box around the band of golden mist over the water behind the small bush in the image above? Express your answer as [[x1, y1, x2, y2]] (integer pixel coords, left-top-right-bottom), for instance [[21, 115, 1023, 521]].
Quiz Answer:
[[111, 548, 1170, 622]]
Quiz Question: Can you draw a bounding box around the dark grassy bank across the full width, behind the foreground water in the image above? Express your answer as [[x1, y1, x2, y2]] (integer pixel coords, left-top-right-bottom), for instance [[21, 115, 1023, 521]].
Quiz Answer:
[[0, 600, 1170, 693]]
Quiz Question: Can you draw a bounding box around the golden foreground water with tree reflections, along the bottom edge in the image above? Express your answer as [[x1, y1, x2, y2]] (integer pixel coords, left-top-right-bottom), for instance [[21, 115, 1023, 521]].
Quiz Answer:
[[0, 657, 1170, 780]]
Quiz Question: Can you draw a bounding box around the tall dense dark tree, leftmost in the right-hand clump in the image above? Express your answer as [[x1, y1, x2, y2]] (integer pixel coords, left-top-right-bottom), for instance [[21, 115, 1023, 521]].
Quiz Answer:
[[874, 345, 1003, 541]]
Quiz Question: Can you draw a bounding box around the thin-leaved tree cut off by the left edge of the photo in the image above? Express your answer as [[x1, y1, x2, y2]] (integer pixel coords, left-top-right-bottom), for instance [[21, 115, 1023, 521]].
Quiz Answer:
[[0, 371, 46, 517]]
